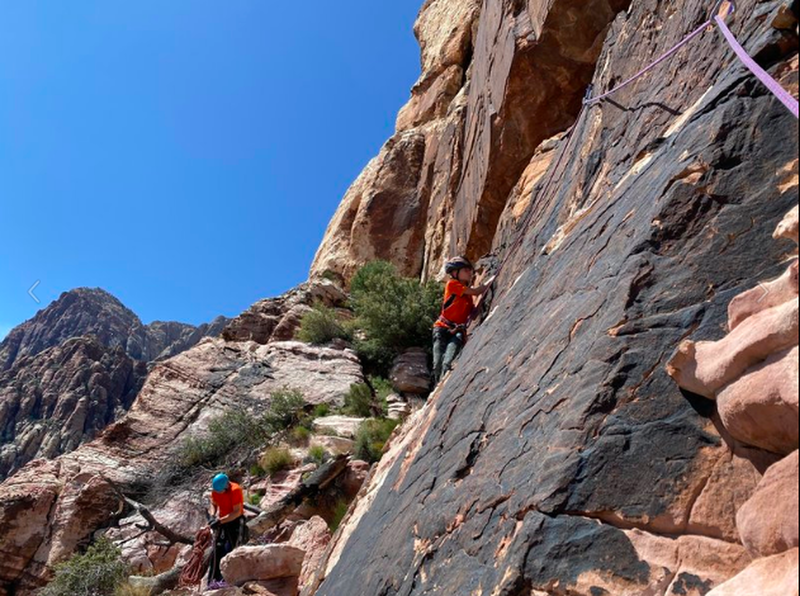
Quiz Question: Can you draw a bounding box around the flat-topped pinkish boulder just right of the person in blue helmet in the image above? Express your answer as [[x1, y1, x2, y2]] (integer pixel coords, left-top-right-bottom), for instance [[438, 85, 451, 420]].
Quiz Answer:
[[220, 544, 305, 586]]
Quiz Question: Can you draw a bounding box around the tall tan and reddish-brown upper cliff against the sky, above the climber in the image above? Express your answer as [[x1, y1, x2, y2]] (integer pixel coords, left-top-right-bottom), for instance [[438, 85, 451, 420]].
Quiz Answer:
[[312, 0, 629, 280]]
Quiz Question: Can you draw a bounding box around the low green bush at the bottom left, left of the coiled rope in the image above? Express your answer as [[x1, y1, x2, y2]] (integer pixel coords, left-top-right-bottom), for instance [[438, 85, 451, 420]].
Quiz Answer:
[[39, 538, 128, 596]]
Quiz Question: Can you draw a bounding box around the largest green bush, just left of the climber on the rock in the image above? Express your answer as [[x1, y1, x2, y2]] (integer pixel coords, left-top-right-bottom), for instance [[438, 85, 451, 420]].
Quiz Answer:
[[350, 261, 442, 374]]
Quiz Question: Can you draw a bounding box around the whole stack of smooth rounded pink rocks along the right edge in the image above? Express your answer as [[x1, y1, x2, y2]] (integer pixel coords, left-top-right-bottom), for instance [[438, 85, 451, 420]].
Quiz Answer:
[[668, 207, 800, 596]]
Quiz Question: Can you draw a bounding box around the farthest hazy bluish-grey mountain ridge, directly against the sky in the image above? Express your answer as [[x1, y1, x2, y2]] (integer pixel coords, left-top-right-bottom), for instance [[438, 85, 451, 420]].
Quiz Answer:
[[0, 288, 228, 371]]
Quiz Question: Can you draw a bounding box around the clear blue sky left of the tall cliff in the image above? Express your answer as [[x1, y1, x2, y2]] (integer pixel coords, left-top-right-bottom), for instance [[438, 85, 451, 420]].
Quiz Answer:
[[0, 0, 422, 337]]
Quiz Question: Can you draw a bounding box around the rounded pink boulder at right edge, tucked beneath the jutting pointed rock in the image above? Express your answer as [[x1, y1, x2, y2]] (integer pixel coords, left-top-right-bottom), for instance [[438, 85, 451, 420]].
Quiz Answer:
[[717, 346, 800, 455]]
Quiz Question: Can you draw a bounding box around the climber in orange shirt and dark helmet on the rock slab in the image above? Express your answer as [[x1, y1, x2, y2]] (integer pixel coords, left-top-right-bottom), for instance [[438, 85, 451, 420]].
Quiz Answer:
[[433, 257, 494, 383]]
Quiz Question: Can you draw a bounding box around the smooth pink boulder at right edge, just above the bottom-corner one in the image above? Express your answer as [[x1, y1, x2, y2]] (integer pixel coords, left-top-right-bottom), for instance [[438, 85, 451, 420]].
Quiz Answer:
[[737, 451, 800, 557]]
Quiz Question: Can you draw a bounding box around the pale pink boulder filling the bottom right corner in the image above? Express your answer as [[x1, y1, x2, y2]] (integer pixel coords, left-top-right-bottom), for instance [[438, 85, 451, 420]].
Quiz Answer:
[[708, 548, 800, 596]]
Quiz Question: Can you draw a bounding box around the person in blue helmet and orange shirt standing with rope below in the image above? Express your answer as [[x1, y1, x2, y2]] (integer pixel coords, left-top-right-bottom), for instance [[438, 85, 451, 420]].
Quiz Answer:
[[208, 474, 247, 583]]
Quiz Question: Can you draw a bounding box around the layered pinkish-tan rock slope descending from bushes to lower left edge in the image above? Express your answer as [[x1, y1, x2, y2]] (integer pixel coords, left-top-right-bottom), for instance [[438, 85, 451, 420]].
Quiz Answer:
[[0, 338, 364, 595]]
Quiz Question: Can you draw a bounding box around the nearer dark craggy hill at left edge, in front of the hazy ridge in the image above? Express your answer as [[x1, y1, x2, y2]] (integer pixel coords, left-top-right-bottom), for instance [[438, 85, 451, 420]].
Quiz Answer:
[[0, 338, 147, 480]]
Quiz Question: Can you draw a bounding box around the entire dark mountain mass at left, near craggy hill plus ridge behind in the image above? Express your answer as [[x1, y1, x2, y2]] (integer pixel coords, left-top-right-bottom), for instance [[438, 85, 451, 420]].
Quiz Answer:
[[0, 288, 228, 479]]
